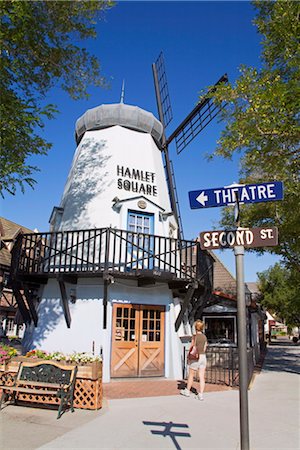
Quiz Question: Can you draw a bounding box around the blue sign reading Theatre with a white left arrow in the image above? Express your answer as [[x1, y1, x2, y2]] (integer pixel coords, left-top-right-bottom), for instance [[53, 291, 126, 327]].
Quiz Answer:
[[189, 181, 283, 209]]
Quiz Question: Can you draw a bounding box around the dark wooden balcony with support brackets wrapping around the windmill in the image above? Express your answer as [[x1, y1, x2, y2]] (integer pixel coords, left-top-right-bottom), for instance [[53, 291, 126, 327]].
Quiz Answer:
[[11, 228, 213, 330]]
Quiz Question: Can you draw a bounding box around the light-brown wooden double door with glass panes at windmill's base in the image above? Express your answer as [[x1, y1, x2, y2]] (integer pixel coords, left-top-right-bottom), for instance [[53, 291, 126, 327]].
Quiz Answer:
[[111, 304, 165, 377]]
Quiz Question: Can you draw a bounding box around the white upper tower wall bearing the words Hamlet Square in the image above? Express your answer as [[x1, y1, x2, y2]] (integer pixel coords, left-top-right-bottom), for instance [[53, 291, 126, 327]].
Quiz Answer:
[[59, 125, 177, 237]]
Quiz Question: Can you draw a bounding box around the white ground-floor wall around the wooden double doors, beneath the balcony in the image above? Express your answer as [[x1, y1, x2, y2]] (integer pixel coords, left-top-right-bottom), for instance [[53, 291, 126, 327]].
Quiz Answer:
[[23, 279, 182, 382]]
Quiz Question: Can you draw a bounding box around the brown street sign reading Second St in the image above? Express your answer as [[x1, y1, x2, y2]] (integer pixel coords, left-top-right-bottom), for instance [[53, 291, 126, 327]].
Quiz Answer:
[[200, 227, 278, 250]]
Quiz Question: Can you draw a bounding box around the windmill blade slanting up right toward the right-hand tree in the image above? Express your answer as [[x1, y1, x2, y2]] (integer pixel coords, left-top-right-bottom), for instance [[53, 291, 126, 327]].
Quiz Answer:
[[167, 74, 228, 154]]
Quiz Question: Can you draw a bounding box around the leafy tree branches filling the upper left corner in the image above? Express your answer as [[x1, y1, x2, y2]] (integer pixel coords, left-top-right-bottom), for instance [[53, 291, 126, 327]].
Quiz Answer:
[[0, 0, 113, 196]]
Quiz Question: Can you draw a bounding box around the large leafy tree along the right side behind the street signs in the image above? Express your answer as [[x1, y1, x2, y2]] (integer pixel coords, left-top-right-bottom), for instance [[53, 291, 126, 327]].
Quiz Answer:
[[206, 0, 300, 271]]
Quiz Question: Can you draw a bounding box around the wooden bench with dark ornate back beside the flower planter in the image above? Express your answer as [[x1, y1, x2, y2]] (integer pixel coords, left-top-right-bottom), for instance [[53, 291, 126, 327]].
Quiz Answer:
[[0, 361, 77, 419]]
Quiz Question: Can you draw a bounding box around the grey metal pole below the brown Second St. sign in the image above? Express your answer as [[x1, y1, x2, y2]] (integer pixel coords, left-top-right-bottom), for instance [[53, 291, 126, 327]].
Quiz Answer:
[[234, 245, 249, 450]]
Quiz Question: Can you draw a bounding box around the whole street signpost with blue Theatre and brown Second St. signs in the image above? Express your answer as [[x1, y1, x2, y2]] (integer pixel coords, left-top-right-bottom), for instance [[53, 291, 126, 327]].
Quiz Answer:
[[189, 181, 283, 450]]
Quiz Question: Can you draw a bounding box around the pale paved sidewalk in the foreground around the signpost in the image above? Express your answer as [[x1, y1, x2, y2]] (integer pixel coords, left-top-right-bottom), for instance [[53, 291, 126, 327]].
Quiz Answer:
[[0, 345, 300, 450]]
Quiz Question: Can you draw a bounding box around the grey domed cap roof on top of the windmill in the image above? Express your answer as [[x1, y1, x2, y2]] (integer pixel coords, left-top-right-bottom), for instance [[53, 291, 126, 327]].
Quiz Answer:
[[75, 103, 163, 143]]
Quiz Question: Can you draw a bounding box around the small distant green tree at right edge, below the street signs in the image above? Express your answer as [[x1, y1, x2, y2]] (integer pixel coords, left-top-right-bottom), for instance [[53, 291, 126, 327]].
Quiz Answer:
[[258, 263, 300, 327]]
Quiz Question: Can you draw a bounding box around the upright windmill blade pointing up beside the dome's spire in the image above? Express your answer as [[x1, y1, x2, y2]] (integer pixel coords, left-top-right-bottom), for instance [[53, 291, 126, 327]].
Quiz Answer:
[[152, 52, 173, 128]]
